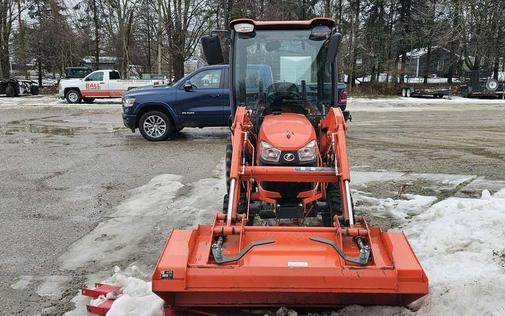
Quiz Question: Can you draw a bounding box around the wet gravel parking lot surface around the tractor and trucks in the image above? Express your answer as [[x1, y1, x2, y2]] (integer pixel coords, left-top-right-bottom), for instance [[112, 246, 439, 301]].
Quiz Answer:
[[0, 96, 505, 315]]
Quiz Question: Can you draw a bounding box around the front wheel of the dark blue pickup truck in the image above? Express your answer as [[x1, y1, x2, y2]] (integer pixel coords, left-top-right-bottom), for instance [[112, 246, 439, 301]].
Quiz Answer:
[[139, 111, 175, 142]]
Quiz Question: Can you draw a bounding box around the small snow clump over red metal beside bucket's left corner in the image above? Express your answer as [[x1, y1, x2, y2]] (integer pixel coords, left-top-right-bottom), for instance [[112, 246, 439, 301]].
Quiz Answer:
[[90, 266, 163, 316]]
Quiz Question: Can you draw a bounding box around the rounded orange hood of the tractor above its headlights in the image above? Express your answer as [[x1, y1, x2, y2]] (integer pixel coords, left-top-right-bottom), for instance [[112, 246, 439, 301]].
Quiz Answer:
[[259, 113, 316, 151]]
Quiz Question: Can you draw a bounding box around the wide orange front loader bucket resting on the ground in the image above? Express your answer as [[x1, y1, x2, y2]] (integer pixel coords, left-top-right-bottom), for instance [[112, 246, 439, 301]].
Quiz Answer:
[[152, 214, 428, 307]]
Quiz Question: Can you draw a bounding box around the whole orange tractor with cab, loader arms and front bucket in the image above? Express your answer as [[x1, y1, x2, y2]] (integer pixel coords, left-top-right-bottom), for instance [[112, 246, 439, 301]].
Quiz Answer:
[[152, 18, 428, 315]]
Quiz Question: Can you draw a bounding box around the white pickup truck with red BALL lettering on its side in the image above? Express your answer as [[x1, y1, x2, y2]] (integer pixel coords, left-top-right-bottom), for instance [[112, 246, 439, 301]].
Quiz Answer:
[[58, 70, 164, 103]]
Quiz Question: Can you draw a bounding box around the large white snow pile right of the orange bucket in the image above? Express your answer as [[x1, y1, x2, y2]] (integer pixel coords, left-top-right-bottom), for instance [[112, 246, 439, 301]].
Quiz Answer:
[[405, 189, 505, 315]]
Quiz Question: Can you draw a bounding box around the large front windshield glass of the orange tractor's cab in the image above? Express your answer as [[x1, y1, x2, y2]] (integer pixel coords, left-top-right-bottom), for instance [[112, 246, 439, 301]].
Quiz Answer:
[[233, 29, 332, 115]]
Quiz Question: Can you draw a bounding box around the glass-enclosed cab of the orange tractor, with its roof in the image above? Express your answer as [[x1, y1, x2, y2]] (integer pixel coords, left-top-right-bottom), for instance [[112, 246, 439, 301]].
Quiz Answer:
[[230, 19, 341, 124]]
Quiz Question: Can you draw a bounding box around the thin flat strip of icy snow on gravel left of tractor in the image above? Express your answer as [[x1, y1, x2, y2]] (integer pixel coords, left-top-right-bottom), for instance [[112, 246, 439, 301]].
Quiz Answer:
[[60, 174, 184, 270]]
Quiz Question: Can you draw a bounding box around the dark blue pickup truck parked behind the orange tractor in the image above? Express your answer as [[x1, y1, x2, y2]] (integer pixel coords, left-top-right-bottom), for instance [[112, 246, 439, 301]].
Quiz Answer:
[[123, 65, 347, 141]]
